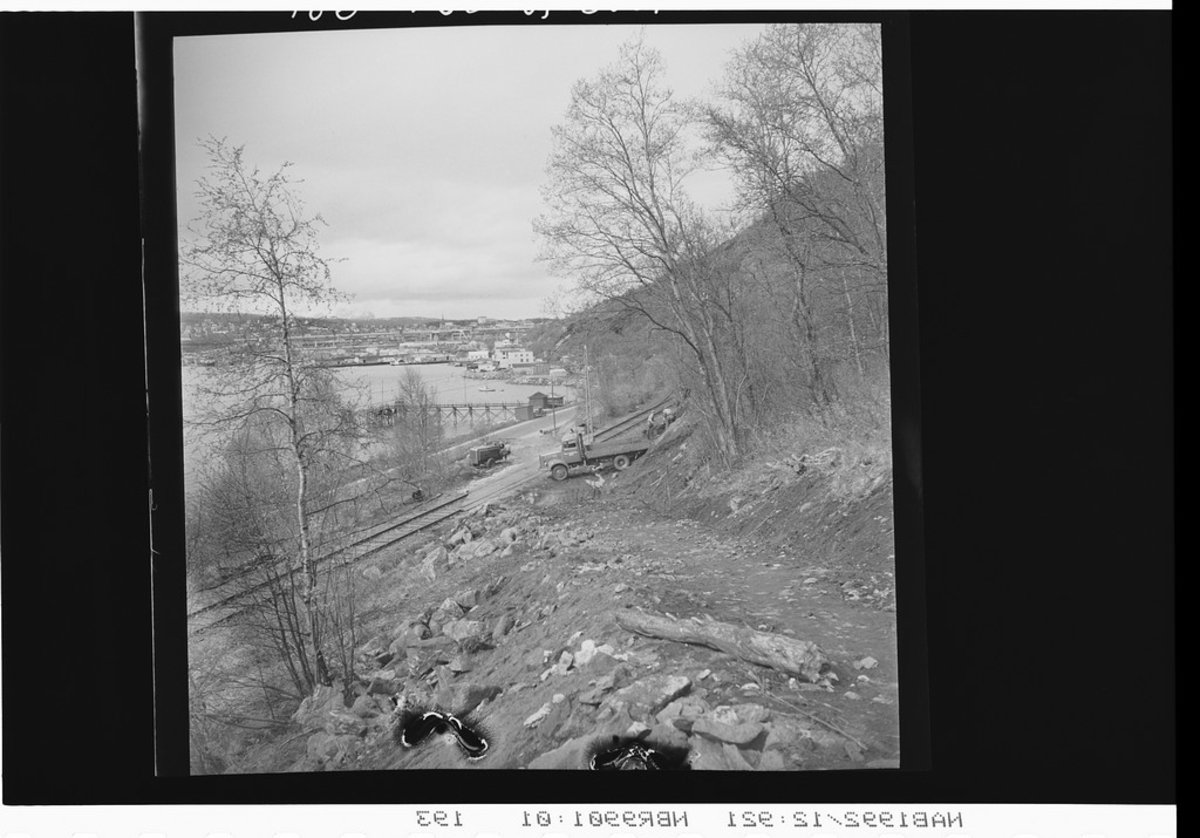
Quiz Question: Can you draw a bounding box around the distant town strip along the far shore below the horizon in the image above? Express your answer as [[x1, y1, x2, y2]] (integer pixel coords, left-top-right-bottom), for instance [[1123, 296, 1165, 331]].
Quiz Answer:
[[180, 312, 552, 373]]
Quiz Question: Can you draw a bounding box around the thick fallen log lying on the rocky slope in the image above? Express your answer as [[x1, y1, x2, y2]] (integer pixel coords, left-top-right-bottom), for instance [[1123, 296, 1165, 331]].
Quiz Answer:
[[613, 611, 828, 683]]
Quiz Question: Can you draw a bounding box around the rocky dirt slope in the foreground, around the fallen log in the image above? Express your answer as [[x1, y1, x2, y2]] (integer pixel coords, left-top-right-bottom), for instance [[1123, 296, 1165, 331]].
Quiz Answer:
[[194, 421, 900, 771]]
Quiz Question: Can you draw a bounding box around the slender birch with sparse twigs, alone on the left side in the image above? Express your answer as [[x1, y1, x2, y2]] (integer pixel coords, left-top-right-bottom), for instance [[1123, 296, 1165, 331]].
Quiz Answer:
[[180, 138, 355, 688]]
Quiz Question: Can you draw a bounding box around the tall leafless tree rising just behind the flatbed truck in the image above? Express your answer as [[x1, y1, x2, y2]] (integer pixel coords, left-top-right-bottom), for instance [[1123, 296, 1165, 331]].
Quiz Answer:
[[535, 36, 740, 460]]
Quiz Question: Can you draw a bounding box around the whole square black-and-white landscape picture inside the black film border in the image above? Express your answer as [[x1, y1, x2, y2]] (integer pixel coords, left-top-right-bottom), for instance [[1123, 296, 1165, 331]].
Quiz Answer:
[[174, 23, 904, 774]]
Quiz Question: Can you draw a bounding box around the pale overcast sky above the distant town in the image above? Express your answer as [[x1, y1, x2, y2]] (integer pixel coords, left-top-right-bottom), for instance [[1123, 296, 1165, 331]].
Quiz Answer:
[[175, 22, 763, 319]]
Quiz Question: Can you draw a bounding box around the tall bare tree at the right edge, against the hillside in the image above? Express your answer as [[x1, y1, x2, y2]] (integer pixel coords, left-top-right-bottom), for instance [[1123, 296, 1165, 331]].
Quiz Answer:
[[706, 24, 887, 406]]
